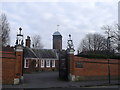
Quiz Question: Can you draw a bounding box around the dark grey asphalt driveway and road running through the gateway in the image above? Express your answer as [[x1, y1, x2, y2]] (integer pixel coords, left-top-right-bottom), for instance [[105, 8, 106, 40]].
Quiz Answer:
[[2, 72, 120, 89]]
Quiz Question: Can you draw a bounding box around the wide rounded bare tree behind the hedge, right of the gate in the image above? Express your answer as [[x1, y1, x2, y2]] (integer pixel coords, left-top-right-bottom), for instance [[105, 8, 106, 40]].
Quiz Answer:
[[79, 33, 107, 52]]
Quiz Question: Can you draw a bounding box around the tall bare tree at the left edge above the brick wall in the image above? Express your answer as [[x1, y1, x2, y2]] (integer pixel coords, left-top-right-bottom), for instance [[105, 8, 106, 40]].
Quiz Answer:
[[0, 14, 10, 46]]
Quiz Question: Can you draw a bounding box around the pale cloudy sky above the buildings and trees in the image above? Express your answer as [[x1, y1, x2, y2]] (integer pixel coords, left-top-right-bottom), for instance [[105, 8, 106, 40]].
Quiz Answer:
[[0, 0, 119, 51]]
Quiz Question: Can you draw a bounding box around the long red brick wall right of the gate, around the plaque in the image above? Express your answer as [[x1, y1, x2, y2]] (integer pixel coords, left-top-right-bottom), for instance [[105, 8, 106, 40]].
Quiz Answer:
[[73, 56, 120, 80]]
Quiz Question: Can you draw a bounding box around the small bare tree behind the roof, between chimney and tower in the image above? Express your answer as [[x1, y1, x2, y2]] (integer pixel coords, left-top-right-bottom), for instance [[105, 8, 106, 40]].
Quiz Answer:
[[32, 35, 43, 49]]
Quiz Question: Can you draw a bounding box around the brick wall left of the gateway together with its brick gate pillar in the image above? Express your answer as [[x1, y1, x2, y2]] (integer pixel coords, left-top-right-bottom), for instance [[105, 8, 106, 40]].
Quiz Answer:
[[0, 46, 23, 84]]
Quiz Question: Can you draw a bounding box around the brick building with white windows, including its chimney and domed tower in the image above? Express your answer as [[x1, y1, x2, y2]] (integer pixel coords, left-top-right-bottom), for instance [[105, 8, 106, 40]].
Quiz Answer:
[[24, 31, 62, 72]]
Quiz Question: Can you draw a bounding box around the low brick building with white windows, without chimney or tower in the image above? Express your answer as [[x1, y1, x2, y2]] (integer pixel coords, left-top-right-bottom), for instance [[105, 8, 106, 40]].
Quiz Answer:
[[24, 47, 59, 72]]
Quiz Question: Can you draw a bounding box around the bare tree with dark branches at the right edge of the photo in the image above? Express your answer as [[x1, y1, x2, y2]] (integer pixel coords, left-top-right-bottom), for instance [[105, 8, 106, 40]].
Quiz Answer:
[[102, 24, 120, 51]]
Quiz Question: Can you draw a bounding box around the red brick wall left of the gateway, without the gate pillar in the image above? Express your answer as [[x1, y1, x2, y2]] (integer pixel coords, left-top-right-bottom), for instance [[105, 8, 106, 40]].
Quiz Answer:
[[0, 51, 16, 84]]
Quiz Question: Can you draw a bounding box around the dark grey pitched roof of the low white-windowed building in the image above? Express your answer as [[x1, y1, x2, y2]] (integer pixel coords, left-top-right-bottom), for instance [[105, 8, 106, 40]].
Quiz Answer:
[[24, 47, 58, 59]]
